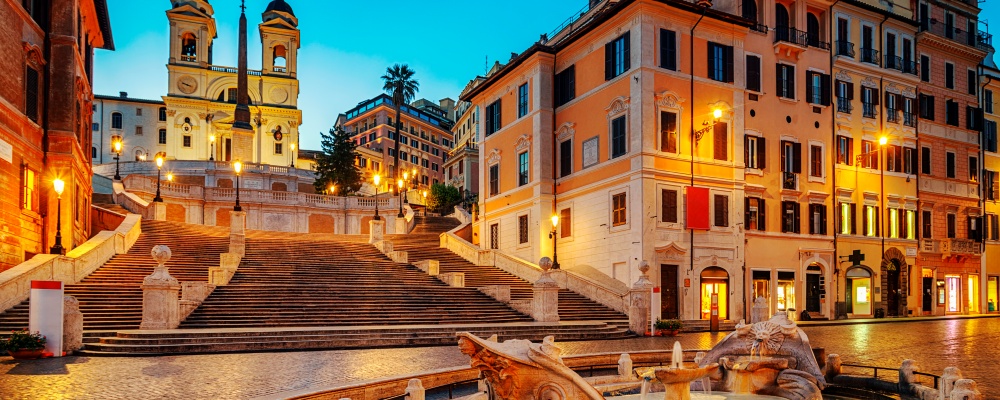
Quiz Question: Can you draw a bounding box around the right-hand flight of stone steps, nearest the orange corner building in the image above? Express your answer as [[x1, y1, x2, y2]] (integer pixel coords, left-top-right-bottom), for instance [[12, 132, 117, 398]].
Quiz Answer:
[[387, 217, 628, 325]]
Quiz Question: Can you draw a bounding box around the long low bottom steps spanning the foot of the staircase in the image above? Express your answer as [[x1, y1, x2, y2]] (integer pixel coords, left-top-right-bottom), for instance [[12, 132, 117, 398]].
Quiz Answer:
[[81, 322, 627, 356]]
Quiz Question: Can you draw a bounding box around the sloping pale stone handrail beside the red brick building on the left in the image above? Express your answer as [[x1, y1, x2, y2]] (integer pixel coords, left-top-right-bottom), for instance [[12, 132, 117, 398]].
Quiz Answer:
[[0, 214, 142, 310]]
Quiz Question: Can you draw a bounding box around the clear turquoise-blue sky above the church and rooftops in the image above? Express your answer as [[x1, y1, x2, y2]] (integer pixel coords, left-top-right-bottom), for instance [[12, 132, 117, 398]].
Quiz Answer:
[[94, 0, 1000, 149]]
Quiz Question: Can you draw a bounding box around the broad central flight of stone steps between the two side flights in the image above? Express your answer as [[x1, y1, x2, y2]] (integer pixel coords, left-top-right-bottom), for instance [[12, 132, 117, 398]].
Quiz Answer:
[[181, 234, 531, 328]]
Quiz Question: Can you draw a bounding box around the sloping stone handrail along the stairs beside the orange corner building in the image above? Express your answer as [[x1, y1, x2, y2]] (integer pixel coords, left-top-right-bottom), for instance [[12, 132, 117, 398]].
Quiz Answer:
[[440, 225, 629, 314]]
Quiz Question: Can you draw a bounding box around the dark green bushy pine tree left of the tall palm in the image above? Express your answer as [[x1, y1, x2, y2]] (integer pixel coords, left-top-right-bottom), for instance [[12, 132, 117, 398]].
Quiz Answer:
[[313, 127, 362, 195]]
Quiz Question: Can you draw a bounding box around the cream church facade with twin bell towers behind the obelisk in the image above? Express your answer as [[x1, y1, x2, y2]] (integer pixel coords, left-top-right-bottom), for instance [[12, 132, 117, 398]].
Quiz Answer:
[[160, 0, 302, 166]]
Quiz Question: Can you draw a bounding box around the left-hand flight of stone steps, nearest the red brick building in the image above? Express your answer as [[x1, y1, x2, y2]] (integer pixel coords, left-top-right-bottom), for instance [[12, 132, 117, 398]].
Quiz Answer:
[[0, 221, 229, 331]]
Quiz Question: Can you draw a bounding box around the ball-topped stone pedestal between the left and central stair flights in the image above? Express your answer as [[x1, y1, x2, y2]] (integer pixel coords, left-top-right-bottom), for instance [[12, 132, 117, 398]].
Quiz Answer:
[[139, 245, 181, 329]]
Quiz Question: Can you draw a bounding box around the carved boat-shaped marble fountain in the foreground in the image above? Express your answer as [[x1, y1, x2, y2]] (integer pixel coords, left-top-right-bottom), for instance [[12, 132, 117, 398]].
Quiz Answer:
[[458, 308, 983, 400]]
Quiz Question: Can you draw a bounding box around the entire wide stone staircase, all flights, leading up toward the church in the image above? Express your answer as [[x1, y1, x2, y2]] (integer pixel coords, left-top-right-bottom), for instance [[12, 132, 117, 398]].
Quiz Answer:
[[0, 214, 627, 355]]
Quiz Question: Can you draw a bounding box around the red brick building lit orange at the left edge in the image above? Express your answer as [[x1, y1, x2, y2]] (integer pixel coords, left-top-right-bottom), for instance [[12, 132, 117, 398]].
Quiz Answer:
[[0, 0, 114, 271]]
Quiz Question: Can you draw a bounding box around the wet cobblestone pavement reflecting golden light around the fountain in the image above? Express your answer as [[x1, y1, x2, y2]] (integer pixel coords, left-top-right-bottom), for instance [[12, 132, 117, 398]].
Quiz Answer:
[[0, 319, 1000, 399]]
